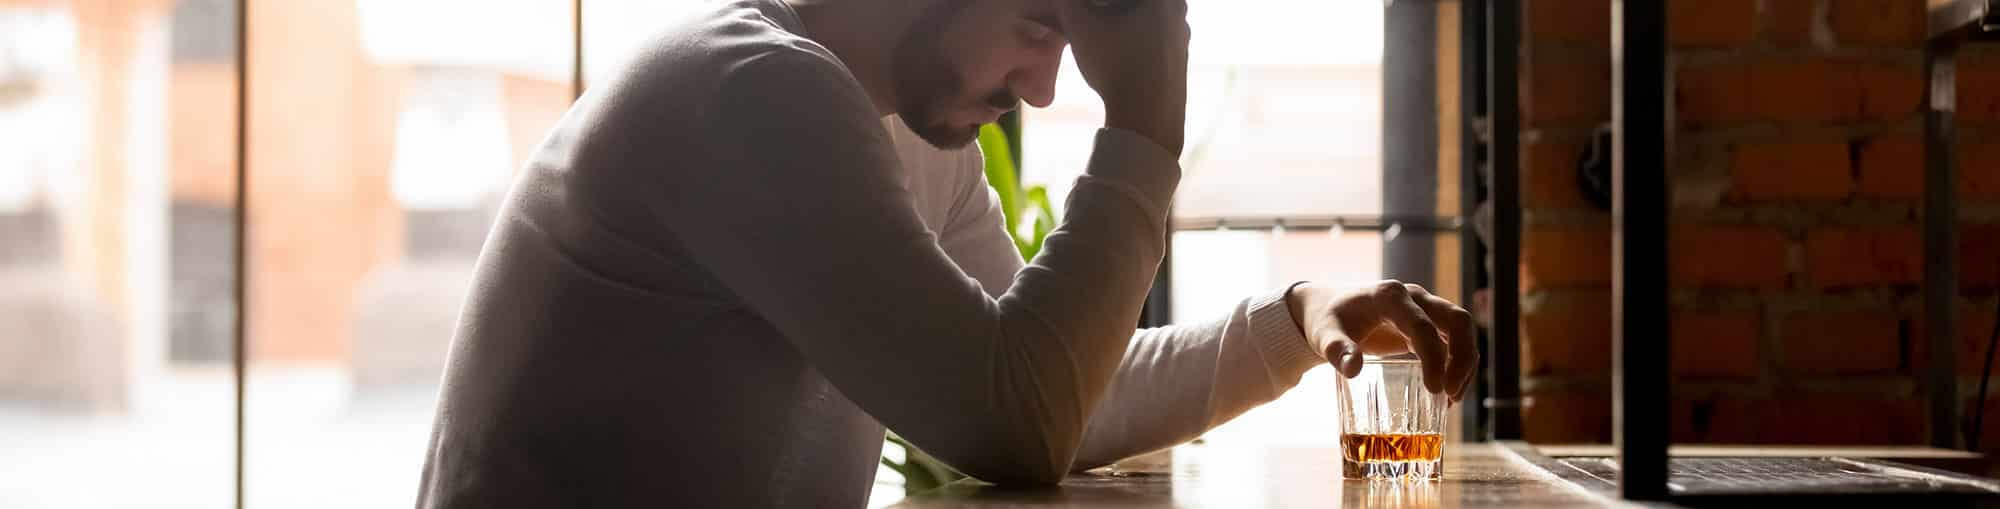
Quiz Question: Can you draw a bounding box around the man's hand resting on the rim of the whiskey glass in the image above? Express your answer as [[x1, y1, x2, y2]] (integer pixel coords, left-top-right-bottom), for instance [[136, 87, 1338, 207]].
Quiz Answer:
[[1286, 281, 1480, 401]]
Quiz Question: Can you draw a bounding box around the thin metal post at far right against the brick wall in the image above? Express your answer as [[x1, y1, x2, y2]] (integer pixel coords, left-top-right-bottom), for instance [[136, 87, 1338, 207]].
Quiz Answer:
[[1924, 38, 1958, 449]]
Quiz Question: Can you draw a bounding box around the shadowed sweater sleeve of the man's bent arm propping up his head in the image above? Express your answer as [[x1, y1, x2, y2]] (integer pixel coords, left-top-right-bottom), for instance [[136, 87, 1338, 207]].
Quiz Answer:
[[652, 52, 1180, 483]]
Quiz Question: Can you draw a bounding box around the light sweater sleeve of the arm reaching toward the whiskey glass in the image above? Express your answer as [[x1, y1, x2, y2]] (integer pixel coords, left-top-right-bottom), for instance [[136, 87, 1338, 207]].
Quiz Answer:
[[938, 124, 1324, 471]]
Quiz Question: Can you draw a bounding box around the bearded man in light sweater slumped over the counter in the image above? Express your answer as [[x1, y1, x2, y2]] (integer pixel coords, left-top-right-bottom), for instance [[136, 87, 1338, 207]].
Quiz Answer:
[[418, 0, 1478, 507]]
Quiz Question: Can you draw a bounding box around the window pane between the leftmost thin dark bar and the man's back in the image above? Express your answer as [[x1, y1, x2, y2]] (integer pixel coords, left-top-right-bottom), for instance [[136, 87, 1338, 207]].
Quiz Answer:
[[244, 0, 574, 507]]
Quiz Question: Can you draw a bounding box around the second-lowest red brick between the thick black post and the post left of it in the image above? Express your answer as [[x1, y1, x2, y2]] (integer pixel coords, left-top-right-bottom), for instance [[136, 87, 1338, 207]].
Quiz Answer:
[[1520, 291, 1612, 375]]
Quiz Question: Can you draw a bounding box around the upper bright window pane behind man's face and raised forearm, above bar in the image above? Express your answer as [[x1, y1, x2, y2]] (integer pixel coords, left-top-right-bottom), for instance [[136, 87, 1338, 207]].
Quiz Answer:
[[1022, 0, 1382, 218]]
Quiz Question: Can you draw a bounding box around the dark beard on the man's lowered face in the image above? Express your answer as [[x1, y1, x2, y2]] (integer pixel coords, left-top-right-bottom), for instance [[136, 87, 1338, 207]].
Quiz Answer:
[[894, 0, 1016, 148]]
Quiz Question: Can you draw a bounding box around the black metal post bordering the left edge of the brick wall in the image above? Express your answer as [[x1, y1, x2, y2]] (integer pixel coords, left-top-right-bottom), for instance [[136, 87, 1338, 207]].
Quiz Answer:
[[1486, 0, 1522, 441]]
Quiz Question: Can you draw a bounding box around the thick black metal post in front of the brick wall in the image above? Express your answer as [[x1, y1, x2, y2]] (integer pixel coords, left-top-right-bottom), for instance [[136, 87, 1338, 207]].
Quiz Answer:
[[1612, 0, 1672, 499]]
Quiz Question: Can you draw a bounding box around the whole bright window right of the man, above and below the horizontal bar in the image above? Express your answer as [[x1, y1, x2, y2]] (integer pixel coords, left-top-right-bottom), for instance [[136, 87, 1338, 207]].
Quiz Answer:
[[1022, 0, 1456, 445]]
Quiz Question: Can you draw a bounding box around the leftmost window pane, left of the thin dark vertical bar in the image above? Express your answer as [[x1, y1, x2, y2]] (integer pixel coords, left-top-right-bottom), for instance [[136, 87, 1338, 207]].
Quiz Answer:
[[0, 0, 236, 507]]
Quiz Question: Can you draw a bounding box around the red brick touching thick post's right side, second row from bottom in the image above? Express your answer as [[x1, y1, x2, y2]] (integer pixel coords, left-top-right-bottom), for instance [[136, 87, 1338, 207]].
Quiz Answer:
[[1672, 311, 1762, 379]]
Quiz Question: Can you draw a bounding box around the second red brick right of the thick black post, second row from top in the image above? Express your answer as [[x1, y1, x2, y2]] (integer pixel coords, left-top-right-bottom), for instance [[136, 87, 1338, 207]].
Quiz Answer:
[[1750, 60, 1862, 124]]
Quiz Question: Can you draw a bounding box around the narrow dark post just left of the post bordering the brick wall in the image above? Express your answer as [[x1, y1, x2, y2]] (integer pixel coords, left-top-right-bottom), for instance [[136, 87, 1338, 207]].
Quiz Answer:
[[1458, 0, 1490, 441]]
